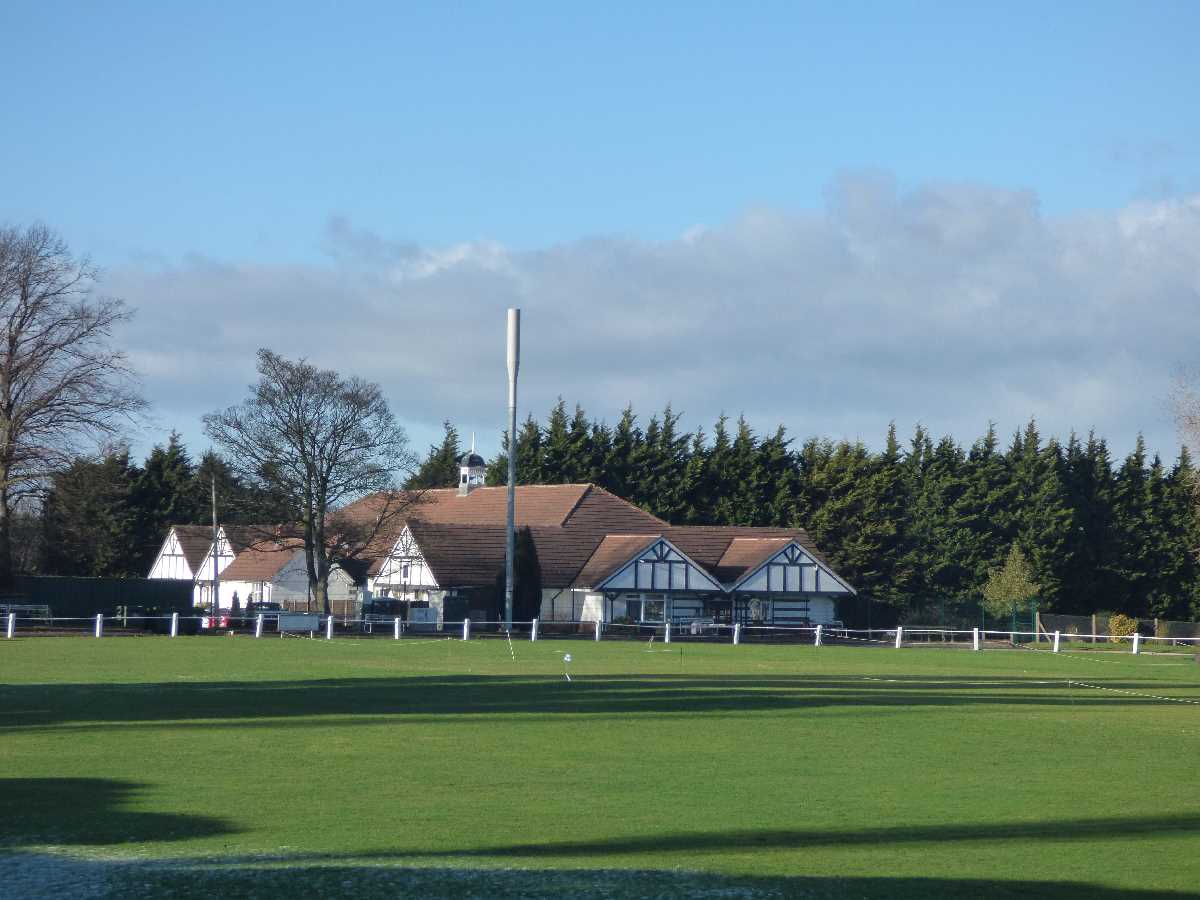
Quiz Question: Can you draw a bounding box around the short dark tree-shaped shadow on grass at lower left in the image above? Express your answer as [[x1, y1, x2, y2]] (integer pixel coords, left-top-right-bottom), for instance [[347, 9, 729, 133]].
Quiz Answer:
[[0, 778, 235, 848]]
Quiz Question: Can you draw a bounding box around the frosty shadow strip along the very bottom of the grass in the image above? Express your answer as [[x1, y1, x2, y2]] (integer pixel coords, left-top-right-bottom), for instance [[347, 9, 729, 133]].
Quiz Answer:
[[0, 854, 1181, 900]]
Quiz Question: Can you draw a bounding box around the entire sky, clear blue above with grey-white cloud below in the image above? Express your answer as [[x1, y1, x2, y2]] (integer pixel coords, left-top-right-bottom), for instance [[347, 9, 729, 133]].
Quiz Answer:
[[0, 2, 1200, 472]]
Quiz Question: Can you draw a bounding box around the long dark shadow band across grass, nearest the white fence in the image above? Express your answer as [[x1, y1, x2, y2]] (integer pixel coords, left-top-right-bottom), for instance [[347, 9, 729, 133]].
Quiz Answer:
[[0, 674, 1196, 731]]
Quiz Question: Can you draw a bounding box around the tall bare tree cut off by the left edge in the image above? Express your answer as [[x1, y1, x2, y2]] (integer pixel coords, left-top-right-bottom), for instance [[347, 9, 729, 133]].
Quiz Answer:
[[0, 224, 145, 586]]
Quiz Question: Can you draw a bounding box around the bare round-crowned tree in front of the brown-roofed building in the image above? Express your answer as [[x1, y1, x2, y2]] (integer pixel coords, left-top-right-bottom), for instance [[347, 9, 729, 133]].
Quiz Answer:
[[204, 349, 415, 613]]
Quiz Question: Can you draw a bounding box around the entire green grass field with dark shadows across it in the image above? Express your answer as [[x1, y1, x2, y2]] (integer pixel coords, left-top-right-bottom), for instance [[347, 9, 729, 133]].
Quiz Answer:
[[0, 636, 1200, 898]]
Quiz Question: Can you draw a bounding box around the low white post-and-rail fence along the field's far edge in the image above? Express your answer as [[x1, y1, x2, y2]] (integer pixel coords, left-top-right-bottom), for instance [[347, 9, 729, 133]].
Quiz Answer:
[[0, 607, 1200, 654]]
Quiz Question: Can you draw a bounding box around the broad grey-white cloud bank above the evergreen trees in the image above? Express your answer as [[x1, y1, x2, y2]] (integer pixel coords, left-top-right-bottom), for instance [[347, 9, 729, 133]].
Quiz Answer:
[[104, 175, 1200, 455]]
